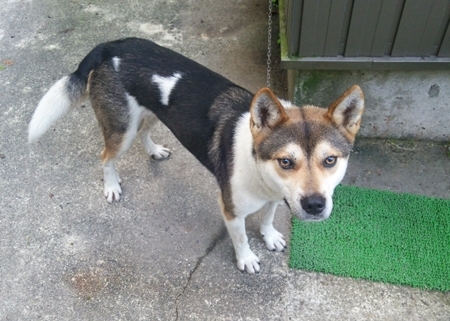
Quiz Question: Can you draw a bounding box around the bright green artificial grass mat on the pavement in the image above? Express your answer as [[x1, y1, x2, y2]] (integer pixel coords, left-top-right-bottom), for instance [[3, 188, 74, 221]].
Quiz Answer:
[[289, 182, 450, 291]]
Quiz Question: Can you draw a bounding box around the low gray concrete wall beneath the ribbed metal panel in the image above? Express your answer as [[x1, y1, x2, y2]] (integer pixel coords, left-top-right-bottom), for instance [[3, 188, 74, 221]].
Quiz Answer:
[[289, 71, 450, 141]]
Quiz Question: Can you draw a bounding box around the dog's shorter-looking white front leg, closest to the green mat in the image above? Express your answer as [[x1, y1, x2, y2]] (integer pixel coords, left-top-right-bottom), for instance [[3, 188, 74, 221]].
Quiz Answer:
[[260, 202, 286, 252]]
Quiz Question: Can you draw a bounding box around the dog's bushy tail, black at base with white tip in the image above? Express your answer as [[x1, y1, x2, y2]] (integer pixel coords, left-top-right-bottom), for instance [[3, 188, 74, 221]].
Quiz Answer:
[[28, 46, 105, 143]]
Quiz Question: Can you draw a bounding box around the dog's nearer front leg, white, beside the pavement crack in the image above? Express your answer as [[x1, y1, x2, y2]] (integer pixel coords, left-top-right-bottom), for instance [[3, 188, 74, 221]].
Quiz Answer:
[[219, 192, 260, 274]]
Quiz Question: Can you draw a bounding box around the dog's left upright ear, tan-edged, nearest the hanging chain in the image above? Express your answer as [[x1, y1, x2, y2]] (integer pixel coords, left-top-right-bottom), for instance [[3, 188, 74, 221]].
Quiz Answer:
[[250, 88, 288, 135]]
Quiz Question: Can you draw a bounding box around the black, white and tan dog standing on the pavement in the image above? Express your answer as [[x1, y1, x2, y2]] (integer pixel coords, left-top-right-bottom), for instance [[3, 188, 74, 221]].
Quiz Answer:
[[28, 38, 364, 274]]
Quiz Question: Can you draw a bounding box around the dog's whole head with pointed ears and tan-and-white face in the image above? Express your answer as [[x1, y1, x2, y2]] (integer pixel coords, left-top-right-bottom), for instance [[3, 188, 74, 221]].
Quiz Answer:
[[250, 86, 364, 221]]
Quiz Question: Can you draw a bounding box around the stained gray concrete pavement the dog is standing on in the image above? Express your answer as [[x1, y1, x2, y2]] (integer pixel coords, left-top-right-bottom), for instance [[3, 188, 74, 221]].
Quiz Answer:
[[0, 0, 450, 321]]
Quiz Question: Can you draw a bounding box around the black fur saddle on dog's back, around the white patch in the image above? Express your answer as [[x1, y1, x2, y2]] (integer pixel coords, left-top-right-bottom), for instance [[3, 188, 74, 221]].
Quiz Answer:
[[74, 38, 253, 183]]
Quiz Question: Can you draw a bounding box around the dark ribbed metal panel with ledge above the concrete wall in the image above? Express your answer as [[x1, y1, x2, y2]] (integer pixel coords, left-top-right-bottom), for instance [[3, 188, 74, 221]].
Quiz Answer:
[[279, 0, 450, 69]]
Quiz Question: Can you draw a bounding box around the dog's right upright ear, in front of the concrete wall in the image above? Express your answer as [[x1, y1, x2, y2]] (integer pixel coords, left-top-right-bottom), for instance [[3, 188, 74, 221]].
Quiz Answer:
[[326, 85, 364, 139]]
